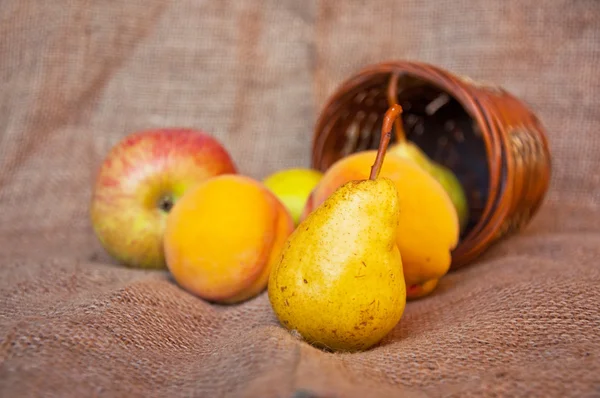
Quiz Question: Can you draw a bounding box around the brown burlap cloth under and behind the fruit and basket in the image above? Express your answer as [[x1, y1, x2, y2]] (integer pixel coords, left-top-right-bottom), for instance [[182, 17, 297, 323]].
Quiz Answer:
[[0, 0, 600, 397]]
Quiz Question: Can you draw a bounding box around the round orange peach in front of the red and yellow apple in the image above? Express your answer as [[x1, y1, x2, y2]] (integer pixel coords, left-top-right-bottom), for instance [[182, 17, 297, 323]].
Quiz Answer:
[[164, 174, 294, 303]]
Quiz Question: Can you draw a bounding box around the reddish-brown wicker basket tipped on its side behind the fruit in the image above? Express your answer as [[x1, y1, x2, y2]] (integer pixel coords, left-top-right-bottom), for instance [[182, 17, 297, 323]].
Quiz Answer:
[[312, 61, 551, 269]]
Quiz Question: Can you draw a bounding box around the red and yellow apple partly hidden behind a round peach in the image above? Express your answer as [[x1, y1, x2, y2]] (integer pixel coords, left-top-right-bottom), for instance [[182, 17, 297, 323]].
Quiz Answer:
[[90, 128, 237, 269]]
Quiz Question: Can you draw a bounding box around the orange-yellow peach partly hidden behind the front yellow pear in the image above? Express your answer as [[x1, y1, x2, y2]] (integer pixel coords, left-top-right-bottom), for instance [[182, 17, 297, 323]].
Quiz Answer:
[[302, 150, 459, 296]]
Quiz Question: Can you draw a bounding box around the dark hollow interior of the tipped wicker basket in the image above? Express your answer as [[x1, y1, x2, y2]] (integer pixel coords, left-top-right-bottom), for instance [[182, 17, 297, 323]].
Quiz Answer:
[[322, 74, 489, 236]]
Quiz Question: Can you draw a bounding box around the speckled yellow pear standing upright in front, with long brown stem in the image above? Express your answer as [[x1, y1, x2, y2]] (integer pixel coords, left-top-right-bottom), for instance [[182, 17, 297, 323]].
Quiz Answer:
[[268, 106, 406, 351]]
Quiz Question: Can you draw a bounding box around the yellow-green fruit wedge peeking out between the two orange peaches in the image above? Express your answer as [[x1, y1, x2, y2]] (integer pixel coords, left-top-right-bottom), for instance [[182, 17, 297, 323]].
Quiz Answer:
[[263, 168, 323, 225]]
